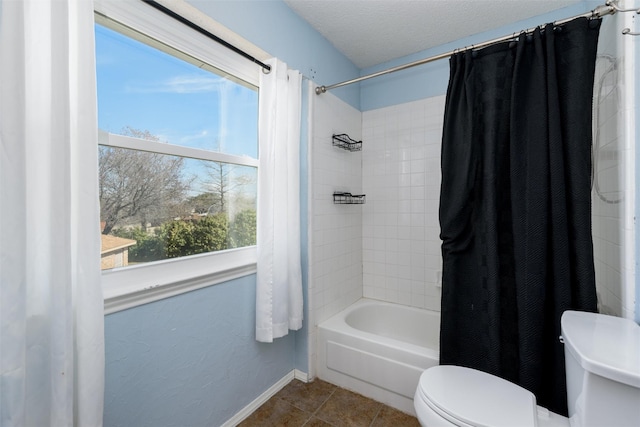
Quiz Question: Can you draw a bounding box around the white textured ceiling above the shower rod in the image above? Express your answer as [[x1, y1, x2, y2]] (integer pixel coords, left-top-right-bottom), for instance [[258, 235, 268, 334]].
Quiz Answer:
[[284, 0, 584, 68]]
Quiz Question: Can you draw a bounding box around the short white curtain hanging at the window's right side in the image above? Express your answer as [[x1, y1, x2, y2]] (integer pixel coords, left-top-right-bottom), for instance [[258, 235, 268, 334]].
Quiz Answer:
[[256, 59, 302, 342]]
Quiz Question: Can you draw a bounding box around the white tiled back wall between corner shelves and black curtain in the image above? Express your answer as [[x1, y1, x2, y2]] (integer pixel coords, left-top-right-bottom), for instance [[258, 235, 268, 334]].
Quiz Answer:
[[362, 96, 445, 310]]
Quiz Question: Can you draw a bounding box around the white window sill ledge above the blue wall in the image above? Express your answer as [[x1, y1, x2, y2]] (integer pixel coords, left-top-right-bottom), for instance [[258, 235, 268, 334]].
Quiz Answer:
[[102, 246, 257, 314]]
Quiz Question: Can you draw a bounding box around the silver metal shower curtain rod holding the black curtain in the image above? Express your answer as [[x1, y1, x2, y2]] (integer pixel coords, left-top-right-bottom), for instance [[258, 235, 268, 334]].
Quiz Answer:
[[316, 0, 616, 95]]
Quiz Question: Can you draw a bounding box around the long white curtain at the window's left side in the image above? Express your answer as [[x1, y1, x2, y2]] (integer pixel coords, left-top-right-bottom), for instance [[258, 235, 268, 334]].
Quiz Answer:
[[0, 0, 104, 427]]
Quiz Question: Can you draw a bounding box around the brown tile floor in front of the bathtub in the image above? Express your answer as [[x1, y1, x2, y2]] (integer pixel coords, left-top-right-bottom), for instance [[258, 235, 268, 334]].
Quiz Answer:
[[240, 379, 420, 427]]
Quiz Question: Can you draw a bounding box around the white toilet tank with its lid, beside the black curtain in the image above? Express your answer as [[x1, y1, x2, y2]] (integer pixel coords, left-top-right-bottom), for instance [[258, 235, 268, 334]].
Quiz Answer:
[[561, 311, 640, 427]]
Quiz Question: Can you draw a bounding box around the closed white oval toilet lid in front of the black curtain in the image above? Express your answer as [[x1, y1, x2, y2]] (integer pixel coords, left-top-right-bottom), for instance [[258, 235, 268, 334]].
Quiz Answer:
[[418, 365, 536, 427]]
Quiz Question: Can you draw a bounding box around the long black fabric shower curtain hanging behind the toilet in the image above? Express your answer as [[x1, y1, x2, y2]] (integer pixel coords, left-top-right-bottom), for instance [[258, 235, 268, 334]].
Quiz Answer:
[[440, 18, 601, 415]]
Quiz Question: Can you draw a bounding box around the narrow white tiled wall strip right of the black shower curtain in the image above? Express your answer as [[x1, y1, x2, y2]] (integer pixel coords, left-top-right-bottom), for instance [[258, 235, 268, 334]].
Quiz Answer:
[[592, 9, 635, 318]]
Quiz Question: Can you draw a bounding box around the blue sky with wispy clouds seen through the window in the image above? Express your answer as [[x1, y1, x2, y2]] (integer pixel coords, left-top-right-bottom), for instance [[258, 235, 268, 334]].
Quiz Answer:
[[96, 25, 258, 157]]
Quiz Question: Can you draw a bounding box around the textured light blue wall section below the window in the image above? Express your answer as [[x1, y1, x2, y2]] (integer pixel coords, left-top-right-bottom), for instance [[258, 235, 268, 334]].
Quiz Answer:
[[104, 275, 295, 427]]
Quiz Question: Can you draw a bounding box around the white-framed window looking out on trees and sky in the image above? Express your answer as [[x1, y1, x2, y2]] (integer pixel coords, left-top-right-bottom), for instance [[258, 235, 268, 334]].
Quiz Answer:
[[95, 2, 259, 311]]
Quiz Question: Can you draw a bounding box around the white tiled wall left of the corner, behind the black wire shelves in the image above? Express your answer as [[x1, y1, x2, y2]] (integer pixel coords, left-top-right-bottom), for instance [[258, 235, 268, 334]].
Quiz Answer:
[[308, 84, 366, 377]]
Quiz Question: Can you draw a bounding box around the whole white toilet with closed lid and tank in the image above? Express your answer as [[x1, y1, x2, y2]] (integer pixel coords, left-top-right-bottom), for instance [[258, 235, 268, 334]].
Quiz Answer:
[[413, 311, 640, 427]]
